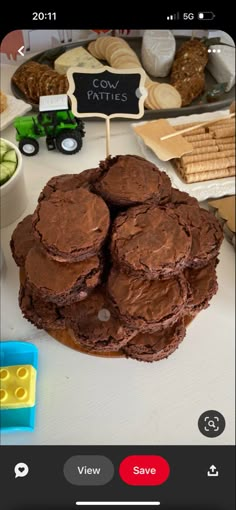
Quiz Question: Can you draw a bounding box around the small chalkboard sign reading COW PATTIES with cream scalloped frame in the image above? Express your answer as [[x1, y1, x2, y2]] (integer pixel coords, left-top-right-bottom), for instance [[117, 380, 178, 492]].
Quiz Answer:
[[67, 66, 146, 119]]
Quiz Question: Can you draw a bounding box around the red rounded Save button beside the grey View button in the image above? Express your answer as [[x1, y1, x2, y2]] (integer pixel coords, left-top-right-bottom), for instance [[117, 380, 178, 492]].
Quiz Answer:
[[119, 455, 170, 485]]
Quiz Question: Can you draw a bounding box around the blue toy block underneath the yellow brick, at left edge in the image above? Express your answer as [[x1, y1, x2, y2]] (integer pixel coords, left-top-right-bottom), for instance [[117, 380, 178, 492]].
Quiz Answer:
[[0, 341, 38, 432]]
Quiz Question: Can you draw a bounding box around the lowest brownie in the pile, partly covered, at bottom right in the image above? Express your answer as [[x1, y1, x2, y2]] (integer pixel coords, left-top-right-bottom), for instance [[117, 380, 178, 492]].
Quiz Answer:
[[123, 319, 186, 362]]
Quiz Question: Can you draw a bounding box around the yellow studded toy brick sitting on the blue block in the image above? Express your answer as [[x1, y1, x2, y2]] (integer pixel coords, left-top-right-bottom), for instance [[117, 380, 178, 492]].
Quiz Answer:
[[0, 365, 37, 409]]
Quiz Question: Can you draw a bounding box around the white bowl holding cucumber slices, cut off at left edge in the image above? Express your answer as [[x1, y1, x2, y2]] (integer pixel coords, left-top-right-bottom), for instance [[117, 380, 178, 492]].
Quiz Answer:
[[0, 137, 27, 228]]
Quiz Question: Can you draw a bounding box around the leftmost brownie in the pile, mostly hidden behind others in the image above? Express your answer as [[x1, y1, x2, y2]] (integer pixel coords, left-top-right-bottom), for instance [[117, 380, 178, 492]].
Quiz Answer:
[[10, 214, 35, 267]]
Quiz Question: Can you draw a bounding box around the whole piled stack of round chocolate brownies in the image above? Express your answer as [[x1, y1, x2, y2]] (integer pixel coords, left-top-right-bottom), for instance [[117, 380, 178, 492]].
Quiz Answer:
[[11, 156, 223, 361]]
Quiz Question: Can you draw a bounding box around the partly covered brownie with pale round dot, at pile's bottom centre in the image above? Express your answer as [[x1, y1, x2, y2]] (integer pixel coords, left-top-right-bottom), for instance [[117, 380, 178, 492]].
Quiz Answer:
[[64, 287, 136, 352]]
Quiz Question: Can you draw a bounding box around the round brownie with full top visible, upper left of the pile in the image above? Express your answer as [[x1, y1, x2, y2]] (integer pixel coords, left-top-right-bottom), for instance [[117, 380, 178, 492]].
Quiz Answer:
[[32, 188, 110, 262]]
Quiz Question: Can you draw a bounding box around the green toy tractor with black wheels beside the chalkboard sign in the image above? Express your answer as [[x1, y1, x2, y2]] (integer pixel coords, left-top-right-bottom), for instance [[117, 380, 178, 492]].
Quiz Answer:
[[14, 94, 85, 156]]
